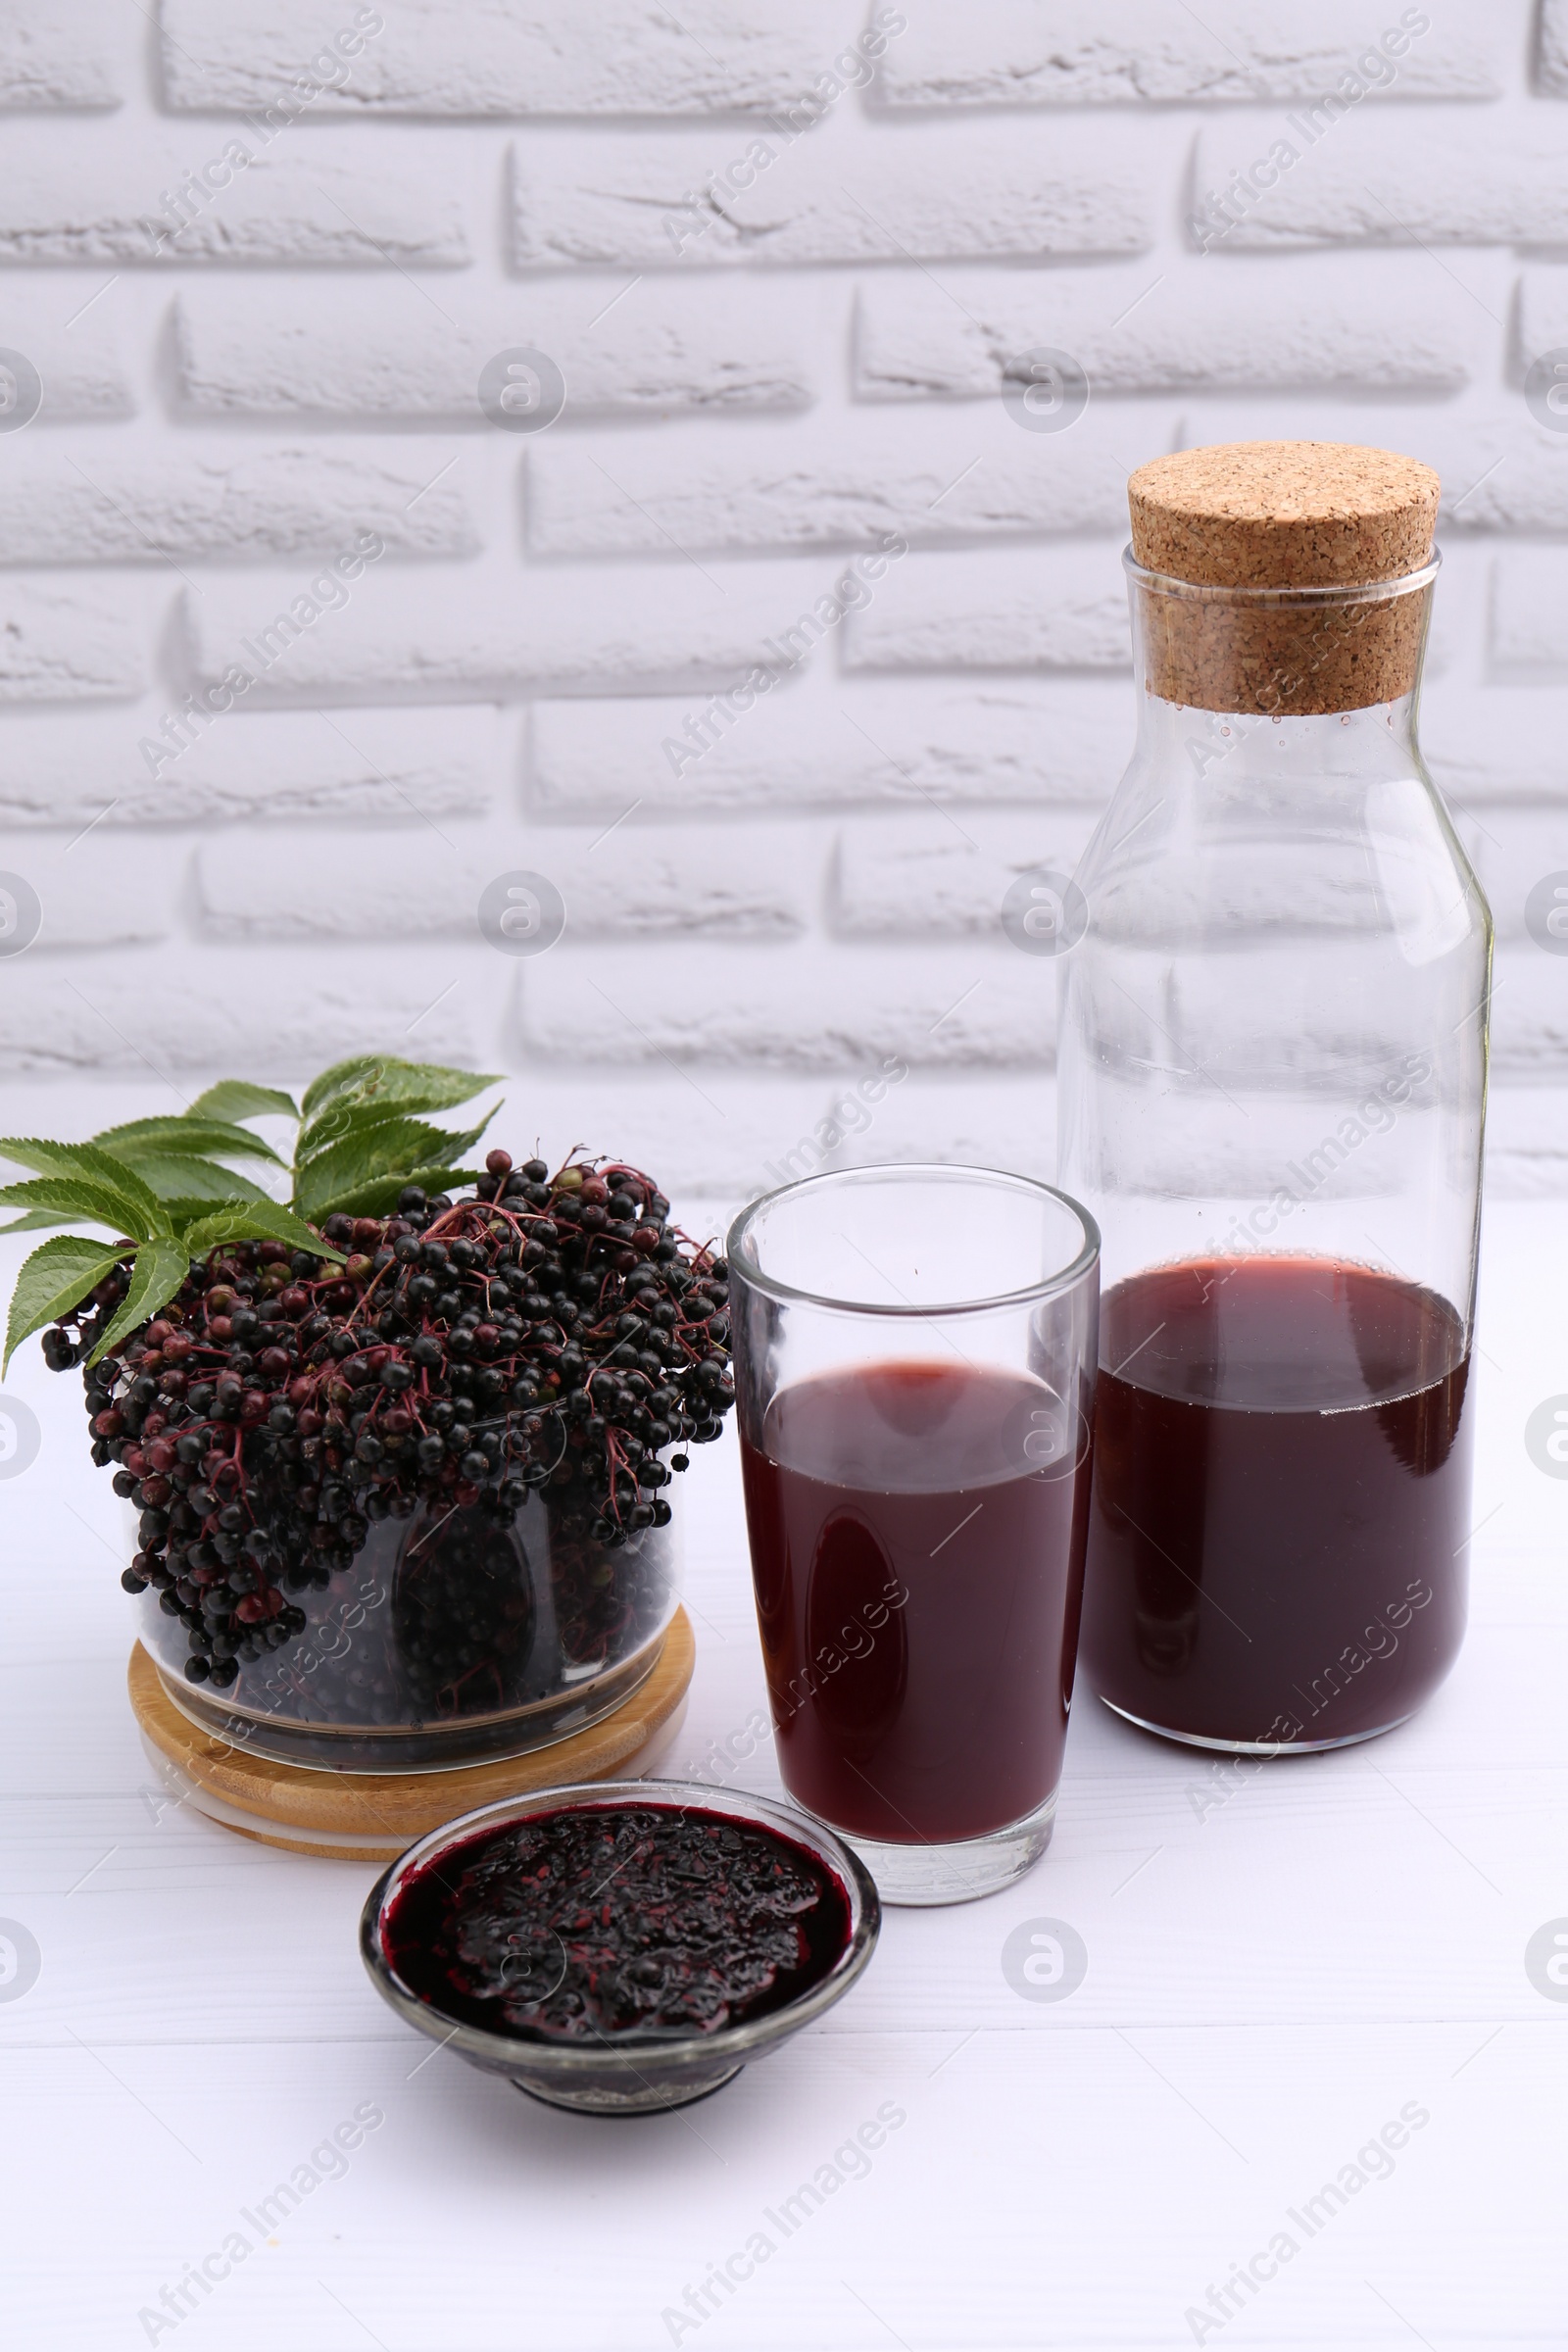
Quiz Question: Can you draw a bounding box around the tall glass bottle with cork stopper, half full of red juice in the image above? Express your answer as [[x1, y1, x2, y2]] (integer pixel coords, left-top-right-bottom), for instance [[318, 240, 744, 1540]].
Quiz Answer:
[[1057, 442, 1493, 1752]]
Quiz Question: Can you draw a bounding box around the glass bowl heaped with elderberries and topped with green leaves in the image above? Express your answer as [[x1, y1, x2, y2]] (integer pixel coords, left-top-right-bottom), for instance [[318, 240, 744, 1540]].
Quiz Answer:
[[0, 1060, 733, 1774]]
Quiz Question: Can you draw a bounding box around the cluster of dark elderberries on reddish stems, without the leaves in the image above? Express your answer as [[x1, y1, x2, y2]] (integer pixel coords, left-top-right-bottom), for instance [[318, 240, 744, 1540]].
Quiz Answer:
[[45, 1152, 733, 1689]]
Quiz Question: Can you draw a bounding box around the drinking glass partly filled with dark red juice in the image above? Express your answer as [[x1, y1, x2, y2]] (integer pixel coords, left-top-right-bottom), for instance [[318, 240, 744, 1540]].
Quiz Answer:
[[729, 1166, 1098, 1903]]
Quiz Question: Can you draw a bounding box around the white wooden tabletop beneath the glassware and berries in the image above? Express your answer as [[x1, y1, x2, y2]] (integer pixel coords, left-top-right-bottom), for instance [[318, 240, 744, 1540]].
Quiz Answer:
[[0, 1201, 1568, 2352]]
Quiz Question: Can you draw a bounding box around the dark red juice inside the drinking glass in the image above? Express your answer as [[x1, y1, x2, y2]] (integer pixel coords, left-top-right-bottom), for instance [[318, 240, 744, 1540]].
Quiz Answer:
[[741, 1362, 1089, 1844]]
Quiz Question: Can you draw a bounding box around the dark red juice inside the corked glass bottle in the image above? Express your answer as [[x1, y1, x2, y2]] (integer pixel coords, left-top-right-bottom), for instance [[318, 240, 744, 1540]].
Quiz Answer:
[[1084, 1258, 1472, 1747]]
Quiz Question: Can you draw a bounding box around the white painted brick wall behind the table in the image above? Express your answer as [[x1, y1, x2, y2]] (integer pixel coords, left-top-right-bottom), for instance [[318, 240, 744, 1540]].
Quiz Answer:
[[0, 0, 1568, 1195]]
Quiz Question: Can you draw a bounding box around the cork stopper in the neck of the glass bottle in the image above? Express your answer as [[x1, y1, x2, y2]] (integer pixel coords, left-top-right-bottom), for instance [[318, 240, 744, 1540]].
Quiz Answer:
[[1128, 442, 1439, 717]]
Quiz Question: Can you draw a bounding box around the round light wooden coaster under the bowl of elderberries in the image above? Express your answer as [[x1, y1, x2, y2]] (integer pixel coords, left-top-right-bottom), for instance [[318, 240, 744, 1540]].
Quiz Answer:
[[129, 1609, 696, 1863]]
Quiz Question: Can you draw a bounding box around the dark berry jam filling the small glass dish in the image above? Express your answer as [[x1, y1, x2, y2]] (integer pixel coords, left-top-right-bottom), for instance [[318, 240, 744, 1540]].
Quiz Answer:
[[385, 1804, 849, 2041]]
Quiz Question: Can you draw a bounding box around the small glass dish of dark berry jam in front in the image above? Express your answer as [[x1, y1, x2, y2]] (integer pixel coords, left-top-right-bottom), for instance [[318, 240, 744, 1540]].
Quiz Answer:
[[360, 1781, 882, 2115]]
